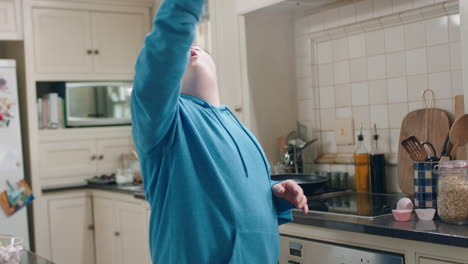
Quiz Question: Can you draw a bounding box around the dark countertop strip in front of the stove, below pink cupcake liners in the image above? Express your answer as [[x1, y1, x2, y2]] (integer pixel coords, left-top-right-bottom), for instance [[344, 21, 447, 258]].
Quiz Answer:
[[293, 210, 468, 248]]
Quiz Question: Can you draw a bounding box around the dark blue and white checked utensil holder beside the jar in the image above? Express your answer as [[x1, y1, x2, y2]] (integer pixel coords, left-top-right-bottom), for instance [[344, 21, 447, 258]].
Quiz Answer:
[[413, 162, 439, 208]]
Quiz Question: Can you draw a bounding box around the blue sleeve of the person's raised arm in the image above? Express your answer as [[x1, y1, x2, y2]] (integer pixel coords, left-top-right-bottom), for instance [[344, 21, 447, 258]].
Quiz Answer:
[[131, 0, 205, 152]]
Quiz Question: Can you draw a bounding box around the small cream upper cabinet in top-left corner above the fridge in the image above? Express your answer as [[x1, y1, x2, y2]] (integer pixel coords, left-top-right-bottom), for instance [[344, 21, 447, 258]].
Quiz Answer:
[[0, 0, 23, 40]]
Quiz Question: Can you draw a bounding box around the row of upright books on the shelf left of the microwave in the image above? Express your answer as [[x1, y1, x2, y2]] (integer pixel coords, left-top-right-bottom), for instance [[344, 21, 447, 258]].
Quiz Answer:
[[37, 93, 65, 129]]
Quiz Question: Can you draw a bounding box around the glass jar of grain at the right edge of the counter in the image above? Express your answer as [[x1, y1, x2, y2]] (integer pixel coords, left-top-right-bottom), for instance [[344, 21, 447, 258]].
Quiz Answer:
[[434, 160, 468, 225]]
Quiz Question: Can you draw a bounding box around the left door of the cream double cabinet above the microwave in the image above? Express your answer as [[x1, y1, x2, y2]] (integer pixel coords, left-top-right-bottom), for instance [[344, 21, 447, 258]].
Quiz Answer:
[[32, 8, 92, 73]]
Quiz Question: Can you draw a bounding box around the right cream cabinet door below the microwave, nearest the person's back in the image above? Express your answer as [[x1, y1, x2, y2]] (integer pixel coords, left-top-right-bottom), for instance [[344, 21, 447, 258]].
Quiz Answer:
[[97, 136, 133, 175]]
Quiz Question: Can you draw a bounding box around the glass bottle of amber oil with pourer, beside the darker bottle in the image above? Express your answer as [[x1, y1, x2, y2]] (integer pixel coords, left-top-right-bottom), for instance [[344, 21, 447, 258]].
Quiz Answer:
[[354, 125, 370, 192]]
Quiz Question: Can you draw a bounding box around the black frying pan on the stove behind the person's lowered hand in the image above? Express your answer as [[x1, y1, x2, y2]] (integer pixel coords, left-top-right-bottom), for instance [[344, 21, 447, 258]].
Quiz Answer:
[[271, 173, 328, 196]]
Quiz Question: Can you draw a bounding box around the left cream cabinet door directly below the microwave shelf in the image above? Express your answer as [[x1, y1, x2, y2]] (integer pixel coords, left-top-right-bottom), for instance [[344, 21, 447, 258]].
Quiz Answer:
[[40, 139, 97, 186]]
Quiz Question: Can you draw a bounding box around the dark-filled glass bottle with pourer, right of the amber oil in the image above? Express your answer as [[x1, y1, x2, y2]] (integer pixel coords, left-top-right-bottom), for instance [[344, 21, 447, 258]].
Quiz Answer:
[[369, 124, 387, 193]]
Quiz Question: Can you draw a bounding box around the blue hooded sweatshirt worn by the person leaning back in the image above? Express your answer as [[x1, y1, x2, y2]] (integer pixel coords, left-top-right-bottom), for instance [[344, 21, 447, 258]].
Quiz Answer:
[[132, 0, 292, 264]]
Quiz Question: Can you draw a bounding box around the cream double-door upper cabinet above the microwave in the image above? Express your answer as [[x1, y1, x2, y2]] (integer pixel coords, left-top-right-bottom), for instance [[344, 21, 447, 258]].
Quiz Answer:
[[32, 7, 150, 74]]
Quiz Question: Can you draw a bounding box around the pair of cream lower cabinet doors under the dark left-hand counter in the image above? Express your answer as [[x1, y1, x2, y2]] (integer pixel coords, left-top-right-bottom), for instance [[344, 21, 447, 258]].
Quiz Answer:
[[43, 190, 151, 264]]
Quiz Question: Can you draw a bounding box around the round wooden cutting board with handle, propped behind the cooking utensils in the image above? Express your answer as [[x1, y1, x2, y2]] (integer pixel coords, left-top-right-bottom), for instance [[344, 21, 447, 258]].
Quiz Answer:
[[398, 90, 450, 195]]
